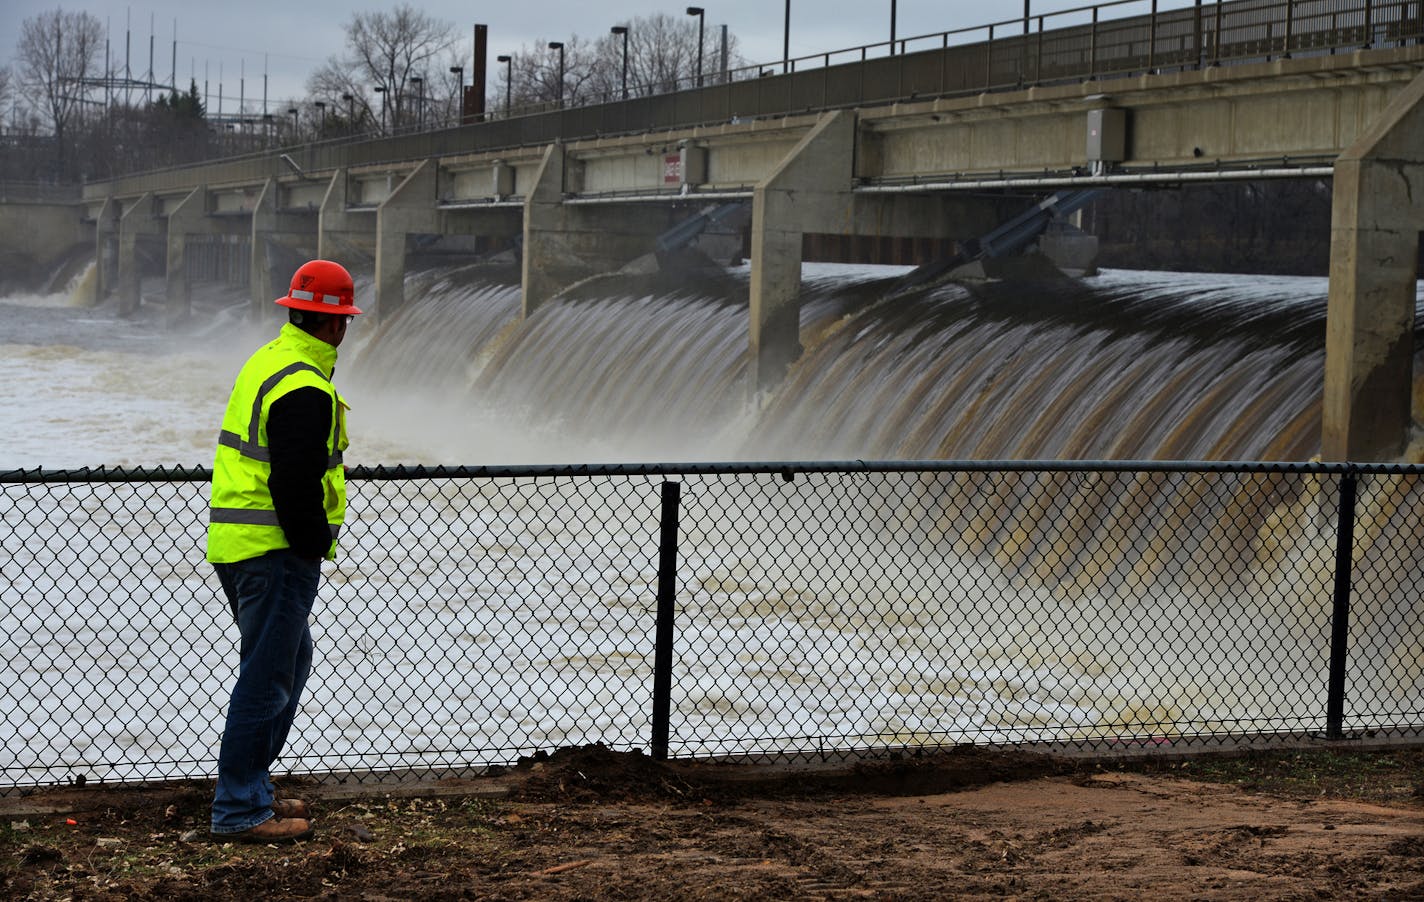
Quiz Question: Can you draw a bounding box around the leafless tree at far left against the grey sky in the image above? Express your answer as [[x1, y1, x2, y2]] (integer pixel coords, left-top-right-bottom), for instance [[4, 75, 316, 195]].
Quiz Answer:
[[17, 10, 104, 177]]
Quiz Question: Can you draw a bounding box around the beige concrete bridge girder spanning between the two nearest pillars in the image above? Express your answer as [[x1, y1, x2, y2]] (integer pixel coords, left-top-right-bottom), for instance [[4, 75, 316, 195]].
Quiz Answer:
[[856, 50, 1418, 181]]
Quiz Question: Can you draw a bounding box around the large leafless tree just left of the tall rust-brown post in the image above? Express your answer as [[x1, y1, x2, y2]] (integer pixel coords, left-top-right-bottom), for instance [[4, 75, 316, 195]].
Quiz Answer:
[[317, 4, 456, 128]]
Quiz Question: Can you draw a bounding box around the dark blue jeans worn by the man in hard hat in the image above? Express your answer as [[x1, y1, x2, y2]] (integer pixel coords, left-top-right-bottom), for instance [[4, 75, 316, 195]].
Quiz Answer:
[[212, 550, 322, 834]]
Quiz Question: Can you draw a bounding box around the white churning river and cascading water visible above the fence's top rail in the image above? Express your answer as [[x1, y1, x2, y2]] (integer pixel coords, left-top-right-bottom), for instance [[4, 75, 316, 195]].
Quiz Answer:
[[0, 265, 1361, 469]]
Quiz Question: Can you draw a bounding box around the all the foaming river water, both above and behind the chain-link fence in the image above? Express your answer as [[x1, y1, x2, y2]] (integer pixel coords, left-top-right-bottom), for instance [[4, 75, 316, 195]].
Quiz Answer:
[[0, 266, 1424, 781]]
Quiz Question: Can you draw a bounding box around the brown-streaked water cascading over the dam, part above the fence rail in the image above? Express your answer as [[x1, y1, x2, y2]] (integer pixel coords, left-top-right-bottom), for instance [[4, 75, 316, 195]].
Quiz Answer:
[[347, 257, 1361, 463]]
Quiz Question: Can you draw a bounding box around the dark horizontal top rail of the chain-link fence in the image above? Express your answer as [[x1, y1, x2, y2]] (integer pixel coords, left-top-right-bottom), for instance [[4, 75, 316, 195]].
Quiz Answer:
[[0, 460, 1406, 484]]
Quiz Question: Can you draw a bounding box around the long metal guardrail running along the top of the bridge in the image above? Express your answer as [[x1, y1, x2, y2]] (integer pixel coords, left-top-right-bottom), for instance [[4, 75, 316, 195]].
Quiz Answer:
[[85, 0, 1424, 198]]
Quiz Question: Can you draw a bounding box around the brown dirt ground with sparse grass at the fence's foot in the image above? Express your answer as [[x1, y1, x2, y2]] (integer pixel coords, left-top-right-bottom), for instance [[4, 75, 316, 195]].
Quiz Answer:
[[0, 747, 1424, 901]]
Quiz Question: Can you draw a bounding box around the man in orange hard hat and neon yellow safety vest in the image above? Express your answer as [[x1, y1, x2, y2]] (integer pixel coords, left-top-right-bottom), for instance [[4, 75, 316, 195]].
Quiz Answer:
[[208, 259, 360, 842]]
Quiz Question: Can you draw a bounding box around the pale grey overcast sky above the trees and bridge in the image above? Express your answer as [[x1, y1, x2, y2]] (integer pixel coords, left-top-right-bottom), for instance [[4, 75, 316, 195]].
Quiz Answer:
[[0, 0, 1192, 111]]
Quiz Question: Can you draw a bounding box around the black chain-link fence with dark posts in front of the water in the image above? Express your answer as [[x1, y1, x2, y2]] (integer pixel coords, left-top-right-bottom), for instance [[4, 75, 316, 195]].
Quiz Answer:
[[0, 463, 1424, 788]]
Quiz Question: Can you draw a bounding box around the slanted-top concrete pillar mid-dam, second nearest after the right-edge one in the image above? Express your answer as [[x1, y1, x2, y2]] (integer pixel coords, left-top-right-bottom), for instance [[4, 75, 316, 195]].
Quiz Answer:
[[750, 110, 856, 390]]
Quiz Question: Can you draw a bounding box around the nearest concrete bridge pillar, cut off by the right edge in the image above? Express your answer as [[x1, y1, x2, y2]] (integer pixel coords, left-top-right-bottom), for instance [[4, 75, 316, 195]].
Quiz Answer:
[[1320, 76, 1424, 460]]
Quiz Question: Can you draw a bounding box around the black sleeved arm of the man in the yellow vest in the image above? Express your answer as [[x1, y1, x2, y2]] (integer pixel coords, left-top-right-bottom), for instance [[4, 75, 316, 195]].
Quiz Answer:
[[268, 388, 332, 559]]
